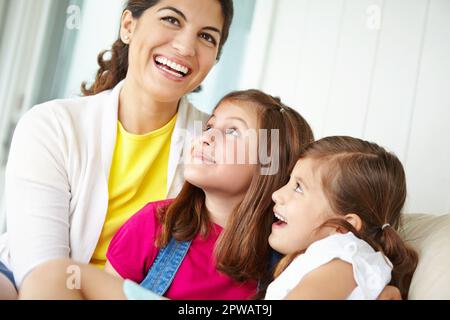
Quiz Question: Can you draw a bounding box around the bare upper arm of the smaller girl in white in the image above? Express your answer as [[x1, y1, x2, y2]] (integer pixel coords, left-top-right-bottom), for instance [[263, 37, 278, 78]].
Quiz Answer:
[[285, 259, 357, 300]]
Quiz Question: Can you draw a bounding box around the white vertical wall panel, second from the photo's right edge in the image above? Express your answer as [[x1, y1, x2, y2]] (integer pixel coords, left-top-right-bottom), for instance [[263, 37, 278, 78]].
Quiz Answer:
[[362, 0, 431, 161]]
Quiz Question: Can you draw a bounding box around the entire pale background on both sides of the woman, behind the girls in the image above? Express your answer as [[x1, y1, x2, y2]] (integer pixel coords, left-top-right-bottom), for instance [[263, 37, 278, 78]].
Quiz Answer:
[[0, 0, 450, 232]]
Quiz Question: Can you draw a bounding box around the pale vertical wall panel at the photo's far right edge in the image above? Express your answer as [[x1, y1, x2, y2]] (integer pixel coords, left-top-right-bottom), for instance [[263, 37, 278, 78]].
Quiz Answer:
[[406, 0, 450, 213]]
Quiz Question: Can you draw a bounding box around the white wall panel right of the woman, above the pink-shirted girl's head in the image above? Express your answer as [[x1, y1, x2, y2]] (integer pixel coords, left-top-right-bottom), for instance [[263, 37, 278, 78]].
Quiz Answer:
[[262, 0, 345, 132]]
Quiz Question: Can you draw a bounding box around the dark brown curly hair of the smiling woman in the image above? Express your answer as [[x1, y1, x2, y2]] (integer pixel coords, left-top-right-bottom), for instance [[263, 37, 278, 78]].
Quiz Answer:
[[81, 0, 234, 96]]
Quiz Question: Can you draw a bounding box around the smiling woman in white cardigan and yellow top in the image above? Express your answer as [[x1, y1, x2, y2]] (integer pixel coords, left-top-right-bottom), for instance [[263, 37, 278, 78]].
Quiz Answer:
[[0, 0, 233, 298]]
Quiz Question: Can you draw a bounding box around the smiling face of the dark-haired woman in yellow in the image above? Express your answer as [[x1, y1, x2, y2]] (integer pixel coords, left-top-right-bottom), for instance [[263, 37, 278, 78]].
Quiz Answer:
[[121, 0, 224, 102]]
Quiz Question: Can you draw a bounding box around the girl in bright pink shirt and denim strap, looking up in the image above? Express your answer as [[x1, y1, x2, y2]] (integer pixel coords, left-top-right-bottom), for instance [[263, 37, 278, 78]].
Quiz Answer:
[[20, 90, 313, 300]]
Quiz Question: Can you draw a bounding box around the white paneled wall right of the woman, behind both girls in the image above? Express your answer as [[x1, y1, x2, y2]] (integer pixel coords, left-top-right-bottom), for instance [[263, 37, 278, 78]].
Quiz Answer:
[[241, 0, 450, 214]]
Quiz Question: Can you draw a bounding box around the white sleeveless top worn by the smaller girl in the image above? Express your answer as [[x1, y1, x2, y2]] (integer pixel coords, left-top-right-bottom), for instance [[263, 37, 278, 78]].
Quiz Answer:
[[265, 232, 392, 300]]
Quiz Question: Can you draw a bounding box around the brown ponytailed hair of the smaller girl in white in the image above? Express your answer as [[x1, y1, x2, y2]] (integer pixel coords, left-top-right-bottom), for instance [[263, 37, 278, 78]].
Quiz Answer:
[[275, 136, 418, 299]]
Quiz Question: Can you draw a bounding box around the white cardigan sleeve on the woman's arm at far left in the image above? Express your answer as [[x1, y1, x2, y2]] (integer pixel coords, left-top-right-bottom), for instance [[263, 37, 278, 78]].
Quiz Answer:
[[5, 106, 71, 286]]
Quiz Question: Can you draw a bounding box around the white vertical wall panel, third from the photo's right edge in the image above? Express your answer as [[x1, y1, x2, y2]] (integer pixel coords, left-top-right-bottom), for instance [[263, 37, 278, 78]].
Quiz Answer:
[[321, 0, 383, 136]]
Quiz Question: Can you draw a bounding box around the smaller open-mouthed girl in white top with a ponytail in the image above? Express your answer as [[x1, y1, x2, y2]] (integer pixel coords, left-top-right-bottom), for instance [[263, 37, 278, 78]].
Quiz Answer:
[[265, 137, 418, 300]]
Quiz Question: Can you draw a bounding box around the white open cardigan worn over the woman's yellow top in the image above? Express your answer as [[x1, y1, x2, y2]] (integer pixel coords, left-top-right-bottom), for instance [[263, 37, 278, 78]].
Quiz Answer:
[[0, 82, 208, 286]]
